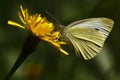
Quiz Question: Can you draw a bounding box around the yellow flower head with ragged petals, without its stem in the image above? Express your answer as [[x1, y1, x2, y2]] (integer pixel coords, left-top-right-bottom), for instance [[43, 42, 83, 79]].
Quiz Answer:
[[8, 6, 68, 55]]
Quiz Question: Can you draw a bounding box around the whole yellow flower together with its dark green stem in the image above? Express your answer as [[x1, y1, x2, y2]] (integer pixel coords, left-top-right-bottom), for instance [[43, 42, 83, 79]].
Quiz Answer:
[[5, 6, 68, 80]]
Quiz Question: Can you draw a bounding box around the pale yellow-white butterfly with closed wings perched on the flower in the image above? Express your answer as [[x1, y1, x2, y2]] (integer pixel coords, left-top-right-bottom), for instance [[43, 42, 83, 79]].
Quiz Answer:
[[61, 18, 114, 60]]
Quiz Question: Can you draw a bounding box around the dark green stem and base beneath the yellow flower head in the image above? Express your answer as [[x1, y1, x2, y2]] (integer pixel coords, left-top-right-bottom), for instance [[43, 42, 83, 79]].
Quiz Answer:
[[4, 35, 39, 80]]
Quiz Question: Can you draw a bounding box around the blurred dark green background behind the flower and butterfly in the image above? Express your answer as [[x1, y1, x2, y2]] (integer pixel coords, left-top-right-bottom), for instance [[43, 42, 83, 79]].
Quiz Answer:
[[0, 0, 120, 80]]
